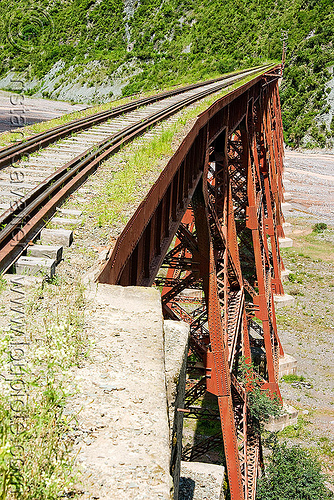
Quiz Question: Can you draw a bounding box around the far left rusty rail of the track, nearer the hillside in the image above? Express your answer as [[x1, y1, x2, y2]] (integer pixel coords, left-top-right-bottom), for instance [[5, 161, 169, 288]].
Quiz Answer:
[[0, 65, 270, 170]]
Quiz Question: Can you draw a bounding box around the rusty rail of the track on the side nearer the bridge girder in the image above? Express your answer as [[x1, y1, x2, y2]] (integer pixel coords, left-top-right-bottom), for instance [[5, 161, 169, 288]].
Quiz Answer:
[[0, 68, 268, 272]]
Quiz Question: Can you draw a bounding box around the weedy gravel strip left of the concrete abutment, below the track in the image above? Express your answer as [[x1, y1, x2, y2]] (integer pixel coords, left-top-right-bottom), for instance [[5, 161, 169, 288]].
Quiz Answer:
[[0, 282, 89, 500]]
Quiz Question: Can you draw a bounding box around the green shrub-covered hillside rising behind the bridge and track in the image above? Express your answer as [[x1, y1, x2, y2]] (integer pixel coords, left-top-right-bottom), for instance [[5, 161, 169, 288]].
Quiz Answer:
[[0, 0, 334, 146]]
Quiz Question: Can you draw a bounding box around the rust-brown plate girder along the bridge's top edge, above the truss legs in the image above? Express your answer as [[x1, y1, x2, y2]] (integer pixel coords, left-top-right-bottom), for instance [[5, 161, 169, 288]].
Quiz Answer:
[[99, 67, 278, 286]]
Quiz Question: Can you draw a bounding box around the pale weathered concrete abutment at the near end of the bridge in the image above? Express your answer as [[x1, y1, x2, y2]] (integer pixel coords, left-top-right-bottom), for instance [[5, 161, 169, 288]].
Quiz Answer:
[[67, 284, 193, 500]]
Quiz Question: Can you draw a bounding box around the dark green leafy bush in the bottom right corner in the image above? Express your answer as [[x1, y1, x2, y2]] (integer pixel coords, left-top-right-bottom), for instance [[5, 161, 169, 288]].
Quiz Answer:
[[256, 443, 333, 500]]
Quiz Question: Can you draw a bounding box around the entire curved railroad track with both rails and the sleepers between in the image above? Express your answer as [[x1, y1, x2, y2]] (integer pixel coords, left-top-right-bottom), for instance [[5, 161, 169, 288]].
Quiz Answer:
[[0, 66, 268, 273]]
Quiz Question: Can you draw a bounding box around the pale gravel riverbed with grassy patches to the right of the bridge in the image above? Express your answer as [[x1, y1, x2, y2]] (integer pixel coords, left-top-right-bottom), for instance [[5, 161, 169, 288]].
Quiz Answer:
[[277, 147, 334, 490]]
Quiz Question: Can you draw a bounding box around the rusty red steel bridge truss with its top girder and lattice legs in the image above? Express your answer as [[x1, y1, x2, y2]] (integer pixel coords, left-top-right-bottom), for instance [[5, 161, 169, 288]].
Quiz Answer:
[[99, 66, 284, 500]]
